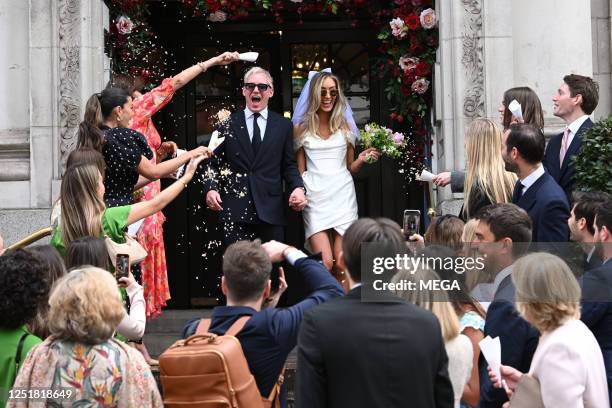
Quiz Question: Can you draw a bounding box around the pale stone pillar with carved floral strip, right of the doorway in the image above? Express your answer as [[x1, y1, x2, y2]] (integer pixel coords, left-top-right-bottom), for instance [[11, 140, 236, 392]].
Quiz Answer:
[[433, 0, 513, 212]]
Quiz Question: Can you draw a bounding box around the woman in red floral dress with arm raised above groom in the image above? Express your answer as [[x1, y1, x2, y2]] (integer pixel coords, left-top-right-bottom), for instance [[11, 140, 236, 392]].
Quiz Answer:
[[113, 52, 238, 318]]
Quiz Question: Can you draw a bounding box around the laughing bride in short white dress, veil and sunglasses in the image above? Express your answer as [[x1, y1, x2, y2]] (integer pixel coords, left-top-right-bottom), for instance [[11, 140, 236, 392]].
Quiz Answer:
[[293, 70, 379, 291]]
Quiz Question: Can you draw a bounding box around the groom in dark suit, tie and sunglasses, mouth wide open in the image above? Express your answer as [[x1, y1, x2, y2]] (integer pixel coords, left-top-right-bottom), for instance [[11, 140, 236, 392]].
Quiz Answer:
[[204, 67, 306, 246]]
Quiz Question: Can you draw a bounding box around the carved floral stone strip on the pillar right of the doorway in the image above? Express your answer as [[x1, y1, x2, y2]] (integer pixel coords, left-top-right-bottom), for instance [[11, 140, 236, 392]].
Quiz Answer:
[[461, 0, 485, 119]]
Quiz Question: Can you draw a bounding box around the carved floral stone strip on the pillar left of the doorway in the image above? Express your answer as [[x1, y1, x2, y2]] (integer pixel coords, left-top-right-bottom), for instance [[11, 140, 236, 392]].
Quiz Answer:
[[58, 0, 81, 168]]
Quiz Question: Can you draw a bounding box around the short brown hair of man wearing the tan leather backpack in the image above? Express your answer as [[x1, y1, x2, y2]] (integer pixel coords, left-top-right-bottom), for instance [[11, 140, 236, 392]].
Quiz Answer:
[[223, 239, 272, 302]]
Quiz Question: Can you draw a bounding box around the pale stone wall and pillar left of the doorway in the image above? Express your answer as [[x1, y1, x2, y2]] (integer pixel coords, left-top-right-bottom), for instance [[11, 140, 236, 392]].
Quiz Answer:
[[0, 0, 108, 243]]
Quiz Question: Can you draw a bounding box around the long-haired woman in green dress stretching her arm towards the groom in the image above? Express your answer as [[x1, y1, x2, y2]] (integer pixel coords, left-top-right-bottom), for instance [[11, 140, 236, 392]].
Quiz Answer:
[[51, 154, 205, 256]]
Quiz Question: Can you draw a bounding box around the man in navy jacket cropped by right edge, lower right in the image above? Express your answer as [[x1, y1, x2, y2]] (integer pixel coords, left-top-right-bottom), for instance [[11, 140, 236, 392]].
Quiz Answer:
[[580, 200, 612, 403]]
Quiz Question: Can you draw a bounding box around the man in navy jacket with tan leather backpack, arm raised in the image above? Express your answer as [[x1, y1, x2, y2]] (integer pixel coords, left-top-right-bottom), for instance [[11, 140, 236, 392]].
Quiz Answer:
[[183, 241, 344, 406]]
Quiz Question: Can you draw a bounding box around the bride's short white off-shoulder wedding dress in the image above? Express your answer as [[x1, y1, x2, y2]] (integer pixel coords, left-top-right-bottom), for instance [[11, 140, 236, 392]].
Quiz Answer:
[[294, 130, 357, 239]]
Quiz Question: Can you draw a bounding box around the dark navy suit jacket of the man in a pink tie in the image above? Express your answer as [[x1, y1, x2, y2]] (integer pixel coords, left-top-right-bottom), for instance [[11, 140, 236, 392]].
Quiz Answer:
[[542, 119, 593, 201]]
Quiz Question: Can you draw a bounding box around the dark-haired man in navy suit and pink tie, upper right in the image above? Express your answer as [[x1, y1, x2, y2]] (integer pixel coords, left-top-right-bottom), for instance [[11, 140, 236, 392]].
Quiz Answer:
[[544, 74, 599, 200]]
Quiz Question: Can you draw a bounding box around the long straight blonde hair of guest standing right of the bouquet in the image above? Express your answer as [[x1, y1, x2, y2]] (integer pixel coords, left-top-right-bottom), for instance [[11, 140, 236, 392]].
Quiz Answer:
[[463, 119, 516, 218]]
